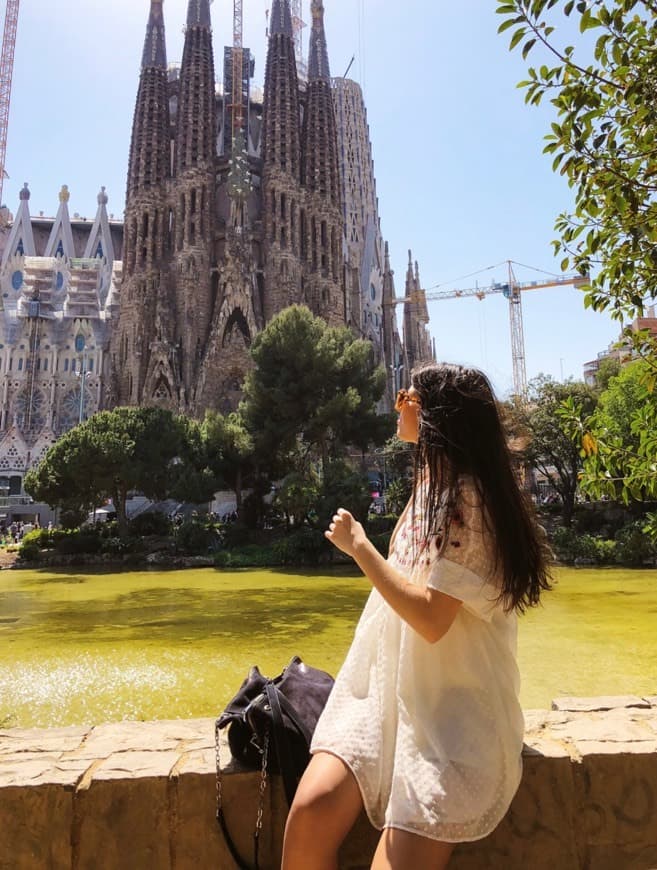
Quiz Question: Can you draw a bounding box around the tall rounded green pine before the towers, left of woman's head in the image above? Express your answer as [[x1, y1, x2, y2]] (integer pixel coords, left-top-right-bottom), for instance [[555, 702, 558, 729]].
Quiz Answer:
[[242, 305, 392, 473]]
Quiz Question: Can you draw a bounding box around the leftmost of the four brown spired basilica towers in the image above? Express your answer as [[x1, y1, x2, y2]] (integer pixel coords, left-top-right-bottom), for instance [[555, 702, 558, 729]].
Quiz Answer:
[[114, 0, 173, 407]]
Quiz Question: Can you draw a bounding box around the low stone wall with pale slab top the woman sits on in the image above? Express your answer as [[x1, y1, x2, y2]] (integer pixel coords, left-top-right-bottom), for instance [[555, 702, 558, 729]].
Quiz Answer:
[[0, 696, 657, 870]]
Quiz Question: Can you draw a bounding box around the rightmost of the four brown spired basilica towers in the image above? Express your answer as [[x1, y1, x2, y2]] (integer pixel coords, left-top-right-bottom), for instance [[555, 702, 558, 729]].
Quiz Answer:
[[302, 0, 346, 326]]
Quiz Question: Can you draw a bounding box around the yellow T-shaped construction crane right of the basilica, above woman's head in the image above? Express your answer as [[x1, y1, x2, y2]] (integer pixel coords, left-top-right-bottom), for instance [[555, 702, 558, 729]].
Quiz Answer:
[[391, 260, 590, 399]]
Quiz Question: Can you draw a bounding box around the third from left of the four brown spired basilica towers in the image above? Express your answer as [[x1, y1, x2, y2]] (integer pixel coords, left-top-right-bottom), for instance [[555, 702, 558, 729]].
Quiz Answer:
[[262, 0, 306, 320]]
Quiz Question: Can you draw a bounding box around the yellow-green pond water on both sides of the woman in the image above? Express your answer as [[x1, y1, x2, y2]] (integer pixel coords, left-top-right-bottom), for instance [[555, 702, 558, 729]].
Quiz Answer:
[[0, 568, 657, 727]]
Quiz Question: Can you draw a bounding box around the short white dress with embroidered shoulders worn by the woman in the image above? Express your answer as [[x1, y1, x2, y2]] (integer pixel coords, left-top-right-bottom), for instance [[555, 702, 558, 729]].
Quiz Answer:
[[311, 480, 524, 843]]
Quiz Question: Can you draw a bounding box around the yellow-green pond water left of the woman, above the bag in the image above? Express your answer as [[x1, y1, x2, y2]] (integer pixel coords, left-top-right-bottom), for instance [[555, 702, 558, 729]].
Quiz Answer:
[[0, 569, 369, 727]]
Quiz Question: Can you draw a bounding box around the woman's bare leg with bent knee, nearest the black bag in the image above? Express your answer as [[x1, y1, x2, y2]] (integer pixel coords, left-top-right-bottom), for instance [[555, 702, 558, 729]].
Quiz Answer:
[[282, 752, 363, 870]]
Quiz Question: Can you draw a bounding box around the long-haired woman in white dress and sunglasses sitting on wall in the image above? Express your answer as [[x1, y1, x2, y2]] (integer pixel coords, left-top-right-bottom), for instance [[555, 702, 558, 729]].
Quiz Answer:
[[283, 365, 550, 870]]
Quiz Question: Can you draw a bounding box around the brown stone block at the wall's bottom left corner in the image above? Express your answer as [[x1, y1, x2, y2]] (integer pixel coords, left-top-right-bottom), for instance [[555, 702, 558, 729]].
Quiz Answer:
[[0, 785, 73, 870]]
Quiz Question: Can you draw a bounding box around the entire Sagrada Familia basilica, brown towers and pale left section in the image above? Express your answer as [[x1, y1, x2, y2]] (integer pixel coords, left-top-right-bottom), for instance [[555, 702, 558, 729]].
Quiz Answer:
[[0, 0, 433, 494]]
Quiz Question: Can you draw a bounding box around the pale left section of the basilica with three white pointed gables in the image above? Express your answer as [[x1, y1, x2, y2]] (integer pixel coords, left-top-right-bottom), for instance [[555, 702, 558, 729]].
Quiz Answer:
[[0, 184, 123, 510]]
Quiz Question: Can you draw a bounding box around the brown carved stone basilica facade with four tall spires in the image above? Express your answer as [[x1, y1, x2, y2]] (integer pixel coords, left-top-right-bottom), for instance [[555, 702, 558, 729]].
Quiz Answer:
[[113, 0, 428, 416]]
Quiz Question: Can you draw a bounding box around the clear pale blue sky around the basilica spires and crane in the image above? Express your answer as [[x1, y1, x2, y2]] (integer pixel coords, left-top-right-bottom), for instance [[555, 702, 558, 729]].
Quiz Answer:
[[3, 0, 619, 394]]
